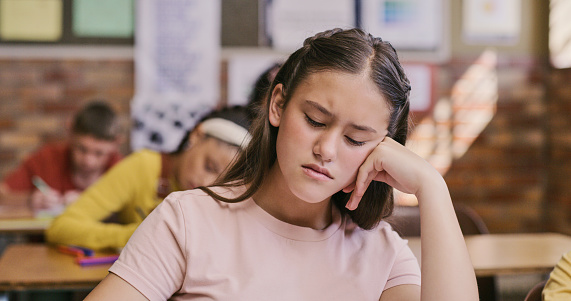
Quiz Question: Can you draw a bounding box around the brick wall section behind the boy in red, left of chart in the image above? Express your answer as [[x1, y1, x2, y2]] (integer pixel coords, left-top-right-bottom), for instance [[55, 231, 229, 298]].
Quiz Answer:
[[0, 59, 133, 176]]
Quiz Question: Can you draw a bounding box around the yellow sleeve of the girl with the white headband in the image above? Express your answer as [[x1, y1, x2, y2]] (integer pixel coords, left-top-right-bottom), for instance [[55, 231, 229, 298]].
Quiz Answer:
[[46, 150, 161, 250]]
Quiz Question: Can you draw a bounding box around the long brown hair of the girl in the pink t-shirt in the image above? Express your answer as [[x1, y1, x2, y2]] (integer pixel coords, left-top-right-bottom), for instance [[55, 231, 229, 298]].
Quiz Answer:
[[200, 29, 410, 229]]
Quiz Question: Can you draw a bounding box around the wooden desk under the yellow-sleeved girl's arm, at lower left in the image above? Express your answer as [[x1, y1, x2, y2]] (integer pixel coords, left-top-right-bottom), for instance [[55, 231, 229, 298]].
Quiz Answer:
[[0, 244, 111, 291]]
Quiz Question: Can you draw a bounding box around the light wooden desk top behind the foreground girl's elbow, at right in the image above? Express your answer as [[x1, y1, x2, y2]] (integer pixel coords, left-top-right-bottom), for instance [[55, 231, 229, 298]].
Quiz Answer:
[[406, 233, 571, 277]]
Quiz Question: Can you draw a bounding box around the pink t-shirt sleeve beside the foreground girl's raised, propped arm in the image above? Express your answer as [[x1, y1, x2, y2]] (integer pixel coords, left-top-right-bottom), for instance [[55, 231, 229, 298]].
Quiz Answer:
[[383, 231, 420, 291]]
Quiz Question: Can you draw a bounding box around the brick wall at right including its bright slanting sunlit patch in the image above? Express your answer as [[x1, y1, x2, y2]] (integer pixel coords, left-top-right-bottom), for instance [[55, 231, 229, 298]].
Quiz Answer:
[[402, 51, 548, 233]]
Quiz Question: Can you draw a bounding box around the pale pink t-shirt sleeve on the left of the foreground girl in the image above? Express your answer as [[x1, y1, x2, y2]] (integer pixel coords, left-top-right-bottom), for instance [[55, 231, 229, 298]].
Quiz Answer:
[[109, 192, 190, 301]]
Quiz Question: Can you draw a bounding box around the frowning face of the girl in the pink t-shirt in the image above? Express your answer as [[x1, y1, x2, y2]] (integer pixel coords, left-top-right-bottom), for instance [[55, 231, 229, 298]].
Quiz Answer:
[[269, 72, 390, 203]]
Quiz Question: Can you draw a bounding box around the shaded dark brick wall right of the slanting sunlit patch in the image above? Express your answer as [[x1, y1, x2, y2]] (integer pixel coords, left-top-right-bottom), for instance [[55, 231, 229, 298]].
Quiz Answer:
[[445, 57, 548, 233]]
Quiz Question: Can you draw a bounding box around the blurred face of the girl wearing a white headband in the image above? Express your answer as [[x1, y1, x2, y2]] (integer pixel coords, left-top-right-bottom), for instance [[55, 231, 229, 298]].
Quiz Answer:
[[173, 134, 238, 189]]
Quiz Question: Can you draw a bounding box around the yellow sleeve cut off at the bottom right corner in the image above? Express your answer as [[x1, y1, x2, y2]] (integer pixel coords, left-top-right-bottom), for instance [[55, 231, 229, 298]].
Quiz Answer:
[[543, 252, 571, 301]]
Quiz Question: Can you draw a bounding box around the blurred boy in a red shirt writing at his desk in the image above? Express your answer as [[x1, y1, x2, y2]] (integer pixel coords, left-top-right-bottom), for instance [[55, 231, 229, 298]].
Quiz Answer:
[[0, 101, 121, 211]]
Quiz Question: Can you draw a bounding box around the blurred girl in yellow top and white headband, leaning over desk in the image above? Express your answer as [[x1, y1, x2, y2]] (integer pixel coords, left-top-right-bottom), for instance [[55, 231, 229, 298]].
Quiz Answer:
[[46, 107, 254, 250]]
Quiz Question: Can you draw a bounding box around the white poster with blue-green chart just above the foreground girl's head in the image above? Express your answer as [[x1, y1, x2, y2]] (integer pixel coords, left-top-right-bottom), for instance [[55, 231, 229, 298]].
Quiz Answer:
[[360, 0, 446, 51]]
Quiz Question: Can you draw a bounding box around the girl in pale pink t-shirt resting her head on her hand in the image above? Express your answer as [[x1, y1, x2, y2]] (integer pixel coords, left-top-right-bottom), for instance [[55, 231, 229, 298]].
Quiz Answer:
[[87, 29, 478, 301]]
